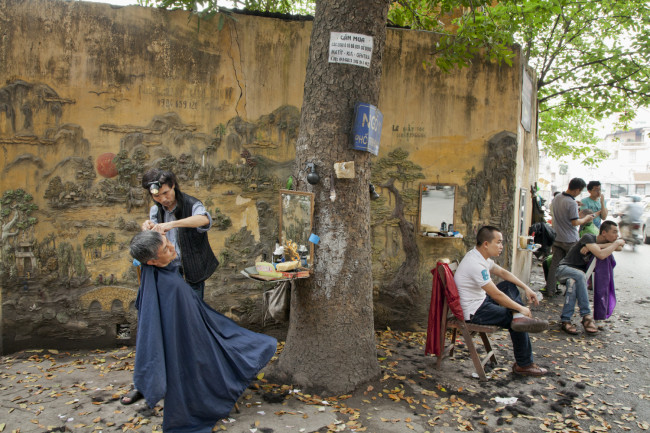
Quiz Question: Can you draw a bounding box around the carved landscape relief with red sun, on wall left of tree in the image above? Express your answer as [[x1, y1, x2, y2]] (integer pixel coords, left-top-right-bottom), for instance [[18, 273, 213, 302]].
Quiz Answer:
[[0, 77, 300, 347]]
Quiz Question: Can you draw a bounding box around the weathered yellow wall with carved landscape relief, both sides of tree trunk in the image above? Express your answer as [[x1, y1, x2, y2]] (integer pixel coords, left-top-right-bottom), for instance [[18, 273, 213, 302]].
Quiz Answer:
[[0, 0, 536, 352]]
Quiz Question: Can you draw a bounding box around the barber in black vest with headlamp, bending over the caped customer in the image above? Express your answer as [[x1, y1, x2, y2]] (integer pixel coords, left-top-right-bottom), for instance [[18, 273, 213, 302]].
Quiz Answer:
[[142, 168, 219, 299]]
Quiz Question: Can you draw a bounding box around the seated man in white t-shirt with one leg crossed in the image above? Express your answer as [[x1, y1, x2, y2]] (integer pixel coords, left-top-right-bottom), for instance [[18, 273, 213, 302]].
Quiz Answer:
[[454, 226, 548, 376]]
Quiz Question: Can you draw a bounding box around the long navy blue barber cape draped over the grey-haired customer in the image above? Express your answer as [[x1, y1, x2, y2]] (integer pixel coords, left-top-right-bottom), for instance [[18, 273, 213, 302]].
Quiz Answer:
[[133, 265, 277, 433]]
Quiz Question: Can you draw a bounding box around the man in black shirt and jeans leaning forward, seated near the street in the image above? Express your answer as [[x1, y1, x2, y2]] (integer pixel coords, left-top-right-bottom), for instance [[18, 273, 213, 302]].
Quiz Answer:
[[556, 221, 625, 335]]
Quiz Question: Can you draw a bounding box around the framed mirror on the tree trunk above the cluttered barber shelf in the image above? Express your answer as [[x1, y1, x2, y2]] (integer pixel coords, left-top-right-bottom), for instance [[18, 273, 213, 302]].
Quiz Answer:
[[279, 189, 314, 268]]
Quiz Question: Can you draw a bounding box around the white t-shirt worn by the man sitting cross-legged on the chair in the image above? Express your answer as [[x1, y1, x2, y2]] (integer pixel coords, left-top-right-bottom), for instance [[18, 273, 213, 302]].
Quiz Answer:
[[454, 248, 494, 320]]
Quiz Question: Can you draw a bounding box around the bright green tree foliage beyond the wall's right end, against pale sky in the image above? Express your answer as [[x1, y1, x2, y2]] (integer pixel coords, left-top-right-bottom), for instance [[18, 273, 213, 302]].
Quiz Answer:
[[480, 0, 650, 164]]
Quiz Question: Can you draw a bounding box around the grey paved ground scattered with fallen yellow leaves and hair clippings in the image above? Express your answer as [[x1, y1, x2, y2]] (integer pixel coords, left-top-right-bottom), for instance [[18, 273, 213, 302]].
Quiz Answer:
[[0, 246, 650, 433]]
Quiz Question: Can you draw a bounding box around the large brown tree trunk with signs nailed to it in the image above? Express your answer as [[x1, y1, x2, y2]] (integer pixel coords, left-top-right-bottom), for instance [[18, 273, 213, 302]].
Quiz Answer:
[[271, 0, 389, 394]]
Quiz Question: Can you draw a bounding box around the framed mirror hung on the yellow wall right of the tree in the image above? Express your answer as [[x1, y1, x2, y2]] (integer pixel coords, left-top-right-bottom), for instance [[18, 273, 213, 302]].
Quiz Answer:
[[418, 182, 456, 236]]
